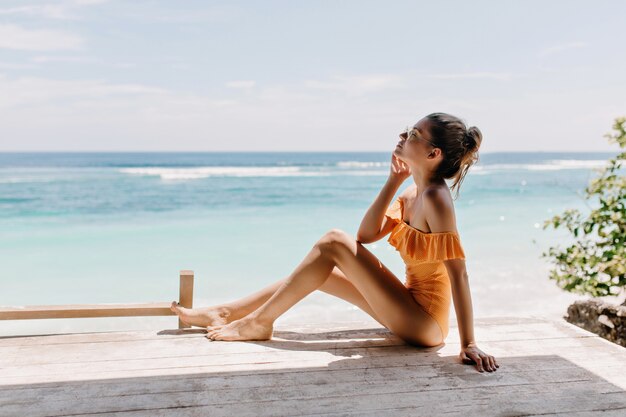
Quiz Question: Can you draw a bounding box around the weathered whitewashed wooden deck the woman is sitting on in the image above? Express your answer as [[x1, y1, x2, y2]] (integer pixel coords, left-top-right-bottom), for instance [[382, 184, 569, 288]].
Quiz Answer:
[[0, 318, 626, 417]]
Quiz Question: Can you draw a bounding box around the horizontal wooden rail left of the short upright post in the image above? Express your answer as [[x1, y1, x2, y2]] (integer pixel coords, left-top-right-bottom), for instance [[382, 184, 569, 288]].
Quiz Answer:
[[0, 303, 176, 320]]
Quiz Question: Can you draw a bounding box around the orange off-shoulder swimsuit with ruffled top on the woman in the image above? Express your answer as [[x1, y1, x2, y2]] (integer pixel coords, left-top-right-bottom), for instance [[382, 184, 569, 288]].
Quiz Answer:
[[385, 197, 465, 339]]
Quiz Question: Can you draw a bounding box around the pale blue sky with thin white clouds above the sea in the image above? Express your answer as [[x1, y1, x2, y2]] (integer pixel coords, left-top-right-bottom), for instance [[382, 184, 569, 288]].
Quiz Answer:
[[0, 0, 626, 152]]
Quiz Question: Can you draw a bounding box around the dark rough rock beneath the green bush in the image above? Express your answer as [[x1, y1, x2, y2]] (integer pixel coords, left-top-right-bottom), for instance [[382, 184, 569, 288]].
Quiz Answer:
[[563, 298, 626, 347]]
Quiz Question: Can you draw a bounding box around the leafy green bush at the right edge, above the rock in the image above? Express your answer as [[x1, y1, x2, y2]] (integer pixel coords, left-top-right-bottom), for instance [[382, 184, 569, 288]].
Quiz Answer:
[[542, 117, 626, 297]]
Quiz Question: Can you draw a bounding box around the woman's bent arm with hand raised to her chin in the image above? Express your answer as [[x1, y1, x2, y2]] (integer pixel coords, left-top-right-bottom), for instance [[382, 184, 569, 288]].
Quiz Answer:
[[356, 155, 411, 243]]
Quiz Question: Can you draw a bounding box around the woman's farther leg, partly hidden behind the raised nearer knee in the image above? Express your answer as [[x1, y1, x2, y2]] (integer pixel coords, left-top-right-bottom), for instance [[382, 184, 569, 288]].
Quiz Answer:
[[171, 267, 382, 327]]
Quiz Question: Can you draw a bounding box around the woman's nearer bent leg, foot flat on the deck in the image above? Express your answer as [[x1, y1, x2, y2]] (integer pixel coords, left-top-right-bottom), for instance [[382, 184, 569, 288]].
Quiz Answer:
[[207, 229, 442, 346]]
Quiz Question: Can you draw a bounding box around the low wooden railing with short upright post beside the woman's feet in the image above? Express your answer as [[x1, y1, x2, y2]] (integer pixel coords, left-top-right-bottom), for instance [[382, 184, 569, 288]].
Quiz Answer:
[[0, 270, 193, 329]]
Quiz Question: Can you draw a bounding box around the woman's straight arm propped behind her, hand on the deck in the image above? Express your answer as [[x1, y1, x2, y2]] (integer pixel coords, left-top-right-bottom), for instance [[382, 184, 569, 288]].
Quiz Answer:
[[424, 189, 500, 372]]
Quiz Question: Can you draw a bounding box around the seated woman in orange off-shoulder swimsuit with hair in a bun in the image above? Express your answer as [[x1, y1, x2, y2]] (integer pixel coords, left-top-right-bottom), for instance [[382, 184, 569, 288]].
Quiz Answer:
[[171, 113, 499, 372]]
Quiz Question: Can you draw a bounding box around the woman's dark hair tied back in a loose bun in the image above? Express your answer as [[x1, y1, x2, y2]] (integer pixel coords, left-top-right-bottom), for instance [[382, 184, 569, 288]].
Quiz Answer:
[[426, 113, 483, 198]]
